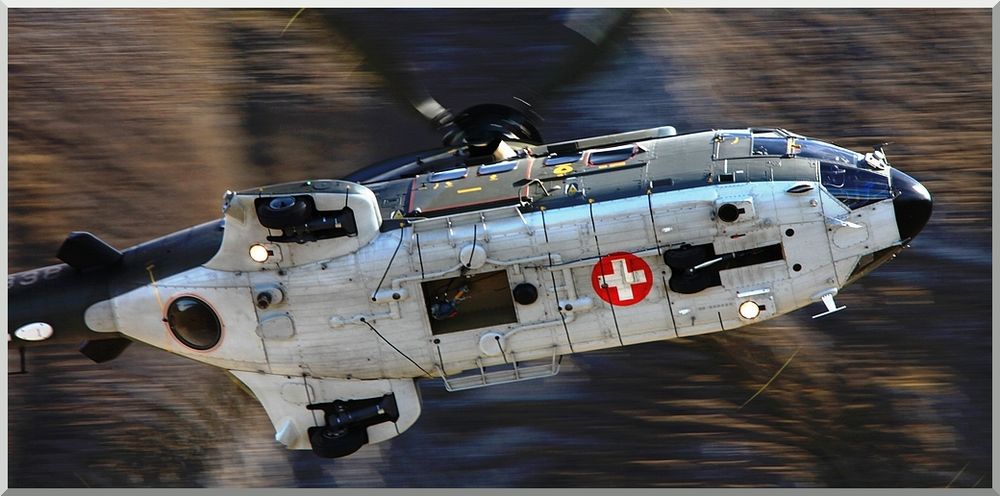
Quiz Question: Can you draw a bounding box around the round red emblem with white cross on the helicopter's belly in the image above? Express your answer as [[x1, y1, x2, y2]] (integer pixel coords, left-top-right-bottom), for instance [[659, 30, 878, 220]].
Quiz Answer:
[[590, 252, 653, 307]]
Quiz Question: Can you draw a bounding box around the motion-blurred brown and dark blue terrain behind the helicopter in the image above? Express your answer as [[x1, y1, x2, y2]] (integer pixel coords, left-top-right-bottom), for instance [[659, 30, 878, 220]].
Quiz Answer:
[[8, 9, 992, 487]]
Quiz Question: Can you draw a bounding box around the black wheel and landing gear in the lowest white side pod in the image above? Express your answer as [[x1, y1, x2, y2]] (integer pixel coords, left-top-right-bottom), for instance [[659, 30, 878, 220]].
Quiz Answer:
[[306, 394, 399, 458]]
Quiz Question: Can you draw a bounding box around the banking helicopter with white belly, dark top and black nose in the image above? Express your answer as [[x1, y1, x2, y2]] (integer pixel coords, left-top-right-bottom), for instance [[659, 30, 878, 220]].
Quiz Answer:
[[8, 10, 932, 458]]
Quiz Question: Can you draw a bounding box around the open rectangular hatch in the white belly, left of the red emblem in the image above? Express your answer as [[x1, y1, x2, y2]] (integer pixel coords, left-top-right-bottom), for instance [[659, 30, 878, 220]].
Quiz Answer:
[[421, 270, 517, 334]]
